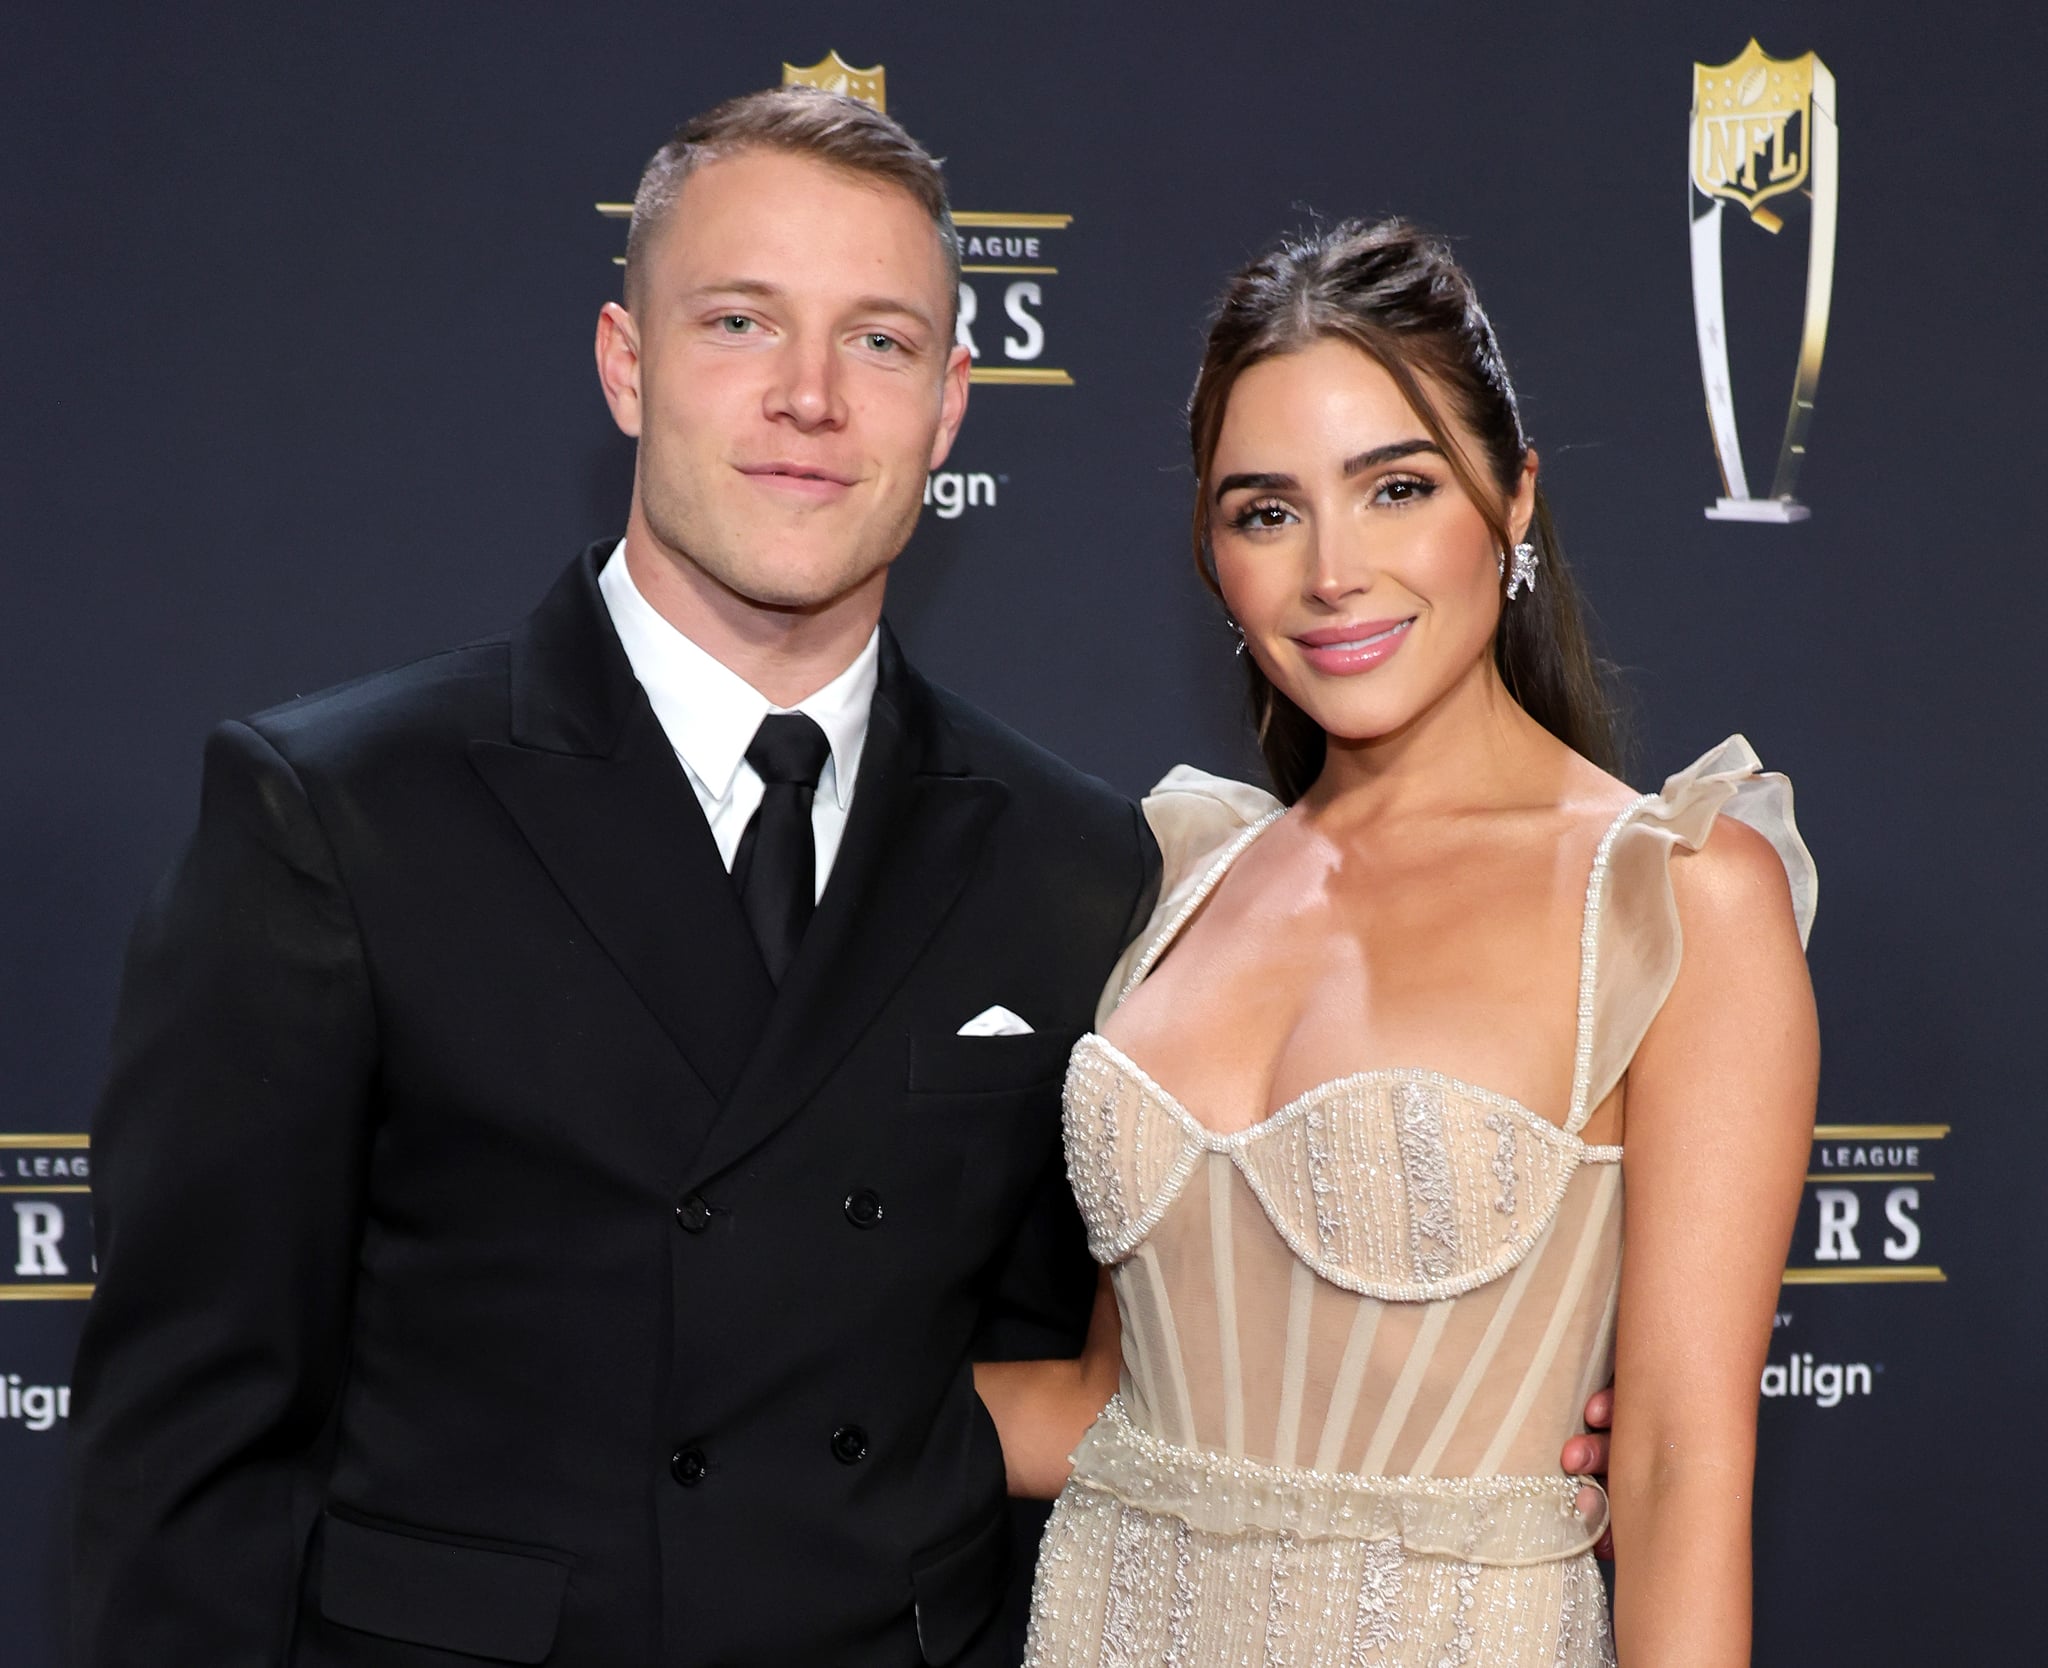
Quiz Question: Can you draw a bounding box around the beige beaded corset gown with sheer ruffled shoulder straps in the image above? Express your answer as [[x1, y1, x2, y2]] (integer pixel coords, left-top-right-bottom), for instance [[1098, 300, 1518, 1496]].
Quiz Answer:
[[1026, 738, 1815, 1668]]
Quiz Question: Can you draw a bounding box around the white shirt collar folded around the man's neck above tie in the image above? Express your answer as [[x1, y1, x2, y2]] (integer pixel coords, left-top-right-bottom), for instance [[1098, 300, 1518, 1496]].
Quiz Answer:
[[598, 539, 881, 811]]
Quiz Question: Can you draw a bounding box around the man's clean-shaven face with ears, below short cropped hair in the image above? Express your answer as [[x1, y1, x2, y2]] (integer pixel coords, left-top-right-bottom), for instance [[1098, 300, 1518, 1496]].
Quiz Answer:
[[598, 150, 967, 611]]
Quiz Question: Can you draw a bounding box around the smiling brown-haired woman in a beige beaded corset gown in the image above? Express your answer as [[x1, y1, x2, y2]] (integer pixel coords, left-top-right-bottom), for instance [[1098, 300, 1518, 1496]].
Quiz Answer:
[[983, 223, 1819, 1668]]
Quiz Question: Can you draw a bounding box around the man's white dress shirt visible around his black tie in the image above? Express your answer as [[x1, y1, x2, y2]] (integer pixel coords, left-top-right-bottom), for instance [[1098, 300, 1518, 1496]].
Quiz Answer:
[[598, 539, 881, 898]]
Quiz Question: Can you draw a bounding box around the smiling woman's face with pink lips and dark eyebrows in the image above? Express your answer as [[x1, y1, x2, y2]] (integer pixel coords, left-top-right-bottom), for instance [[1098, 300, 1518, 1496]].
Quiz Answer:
[[1208, 338, 1536, 742]]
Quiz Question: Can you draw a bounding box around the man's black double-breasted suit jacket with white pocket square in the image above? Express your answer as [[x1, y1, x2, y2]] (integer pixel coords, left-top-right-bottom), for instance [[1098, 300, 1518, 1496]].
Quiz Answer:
[[74, 547, 1157, 1668]]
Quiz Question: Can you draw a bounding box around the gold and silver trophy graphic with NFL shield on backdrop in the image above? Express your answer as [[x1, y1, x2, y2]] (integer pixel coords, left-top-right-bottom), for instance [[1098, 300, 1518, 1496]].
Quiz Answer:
[[1688, 39, 1841, 523]]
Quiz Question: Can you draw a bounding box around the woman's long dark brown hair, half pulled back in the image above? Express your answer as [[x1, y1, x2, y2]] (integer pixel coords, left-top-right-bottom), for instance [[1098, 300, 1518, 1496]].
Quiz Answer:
[[1188, 219, 1620, 805]]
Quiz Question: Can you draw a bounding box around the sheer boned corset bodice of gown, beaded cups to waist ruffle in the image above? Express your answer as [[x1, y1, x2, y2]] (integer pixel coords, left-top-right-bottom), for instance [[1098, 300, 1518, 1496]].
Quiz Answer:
[[1067, 1037, 1622, 1491]]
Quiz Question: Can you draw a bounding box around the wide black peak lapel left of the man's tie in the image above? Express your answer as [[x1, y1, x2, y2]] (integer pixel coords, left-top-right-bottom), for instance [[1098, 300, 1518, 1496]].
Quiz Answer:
[[469, 545, 774, 1102]]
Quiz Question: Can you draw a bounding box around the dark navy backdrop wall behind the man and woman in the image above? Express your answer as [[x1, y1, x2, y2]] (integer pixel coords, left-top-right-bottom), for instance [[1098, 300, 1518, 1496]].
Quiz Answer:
[[0, 0, 2048, 1668]]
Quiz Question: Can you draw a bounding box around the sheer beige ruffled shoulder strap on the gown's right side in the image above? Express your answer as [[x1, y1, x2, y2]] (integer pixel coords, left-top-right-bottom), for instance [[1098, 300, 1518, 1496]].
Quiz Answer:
[[1573, 736, 1819, 1127]]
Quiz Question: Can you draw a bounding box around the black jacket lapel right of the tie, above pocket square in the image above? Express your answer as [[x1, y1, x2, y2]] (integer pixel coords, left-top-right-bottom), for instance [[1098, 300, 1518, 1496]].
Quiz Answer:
[[690, 629, 1008, 1182]]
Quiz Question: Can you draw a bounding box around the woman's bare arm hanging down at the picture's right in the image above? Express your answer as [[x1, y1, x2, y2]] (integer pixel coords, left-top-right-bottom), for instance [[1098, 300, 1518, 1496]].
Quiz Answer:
[[1608, 818, 1821, 1668]]
